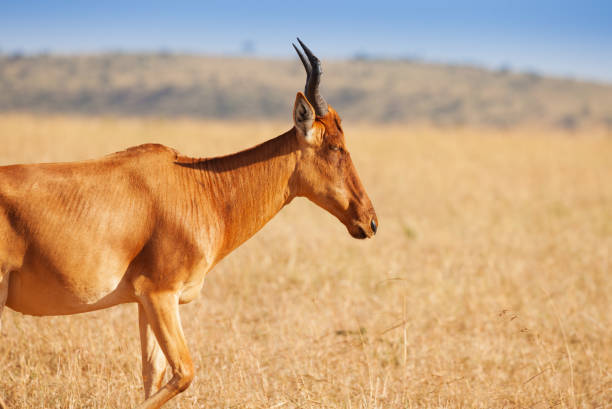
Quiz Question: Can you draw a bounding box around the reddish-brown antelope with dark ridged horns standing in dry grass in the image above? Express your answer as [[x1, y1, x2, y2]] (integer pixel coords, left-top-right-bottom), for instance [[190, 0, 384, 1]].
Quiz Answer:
[[0, 38, 378, 409]]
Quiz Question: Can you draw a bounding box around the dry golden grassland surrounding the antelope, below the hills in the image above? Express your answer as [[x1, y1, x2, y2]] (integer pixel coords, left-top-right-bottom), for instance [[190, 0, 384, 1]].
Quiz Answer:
[[0, 114, 612, 409]]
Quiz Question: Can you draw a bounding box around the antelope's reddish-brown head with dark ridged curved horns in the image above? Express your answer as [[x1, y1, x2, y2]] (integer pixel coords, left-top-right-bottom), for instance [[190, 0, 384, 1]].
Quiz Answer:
[[293, 38, 378, 239]]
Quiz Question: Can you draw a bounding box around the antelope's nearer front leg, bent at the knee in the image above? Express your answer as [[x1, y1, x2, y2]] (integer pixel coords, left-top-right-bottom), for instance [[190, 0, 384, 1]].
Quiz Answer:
[[138, 292, 194, 409]]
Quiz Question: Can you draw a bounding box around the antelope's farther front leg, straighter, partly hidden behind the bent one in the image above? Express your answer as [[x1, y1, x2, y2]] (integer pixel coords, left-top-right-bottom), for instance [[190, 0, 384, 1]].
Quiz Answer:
[[138, 304, 168, 399]]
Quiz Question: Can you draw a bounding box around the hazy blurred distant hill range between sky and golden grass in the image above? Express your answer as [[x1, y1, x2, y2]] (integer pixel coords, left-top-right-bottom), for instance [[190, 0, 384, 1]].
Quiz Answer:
[[0, 54, 612, 129]]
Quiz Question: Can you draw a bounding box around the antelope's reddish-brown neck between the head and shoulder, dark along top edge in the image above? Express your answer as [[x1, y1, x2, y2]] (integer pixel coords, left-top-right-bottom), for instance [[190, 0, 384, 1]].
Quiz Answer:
[[189, 130, 297, 259]]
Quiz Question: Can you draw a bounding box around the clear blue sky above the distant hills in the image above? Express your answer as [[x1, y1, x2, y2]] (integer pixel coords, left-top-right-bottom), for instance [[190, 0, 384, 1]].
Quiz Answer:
[[0, 0, 612, 82]]
